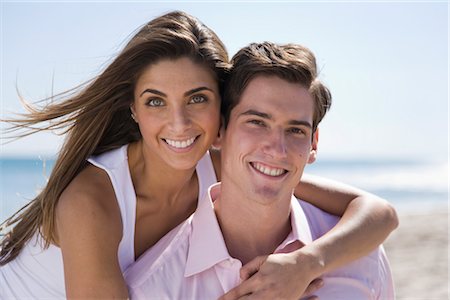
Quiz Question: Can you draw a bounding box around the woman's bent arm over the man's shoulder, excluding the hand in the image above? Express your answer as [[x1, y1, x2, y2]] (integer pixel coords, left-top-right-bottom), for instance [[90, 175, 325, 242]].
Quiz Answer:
[[294, 175, 398, 260]]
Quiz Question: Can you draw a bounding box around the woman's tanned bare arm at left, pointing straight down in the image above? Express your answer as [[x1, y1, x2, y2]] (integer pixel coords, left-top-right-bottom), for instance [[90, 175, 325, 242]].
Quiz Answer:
[[56, 166, 128, 299]]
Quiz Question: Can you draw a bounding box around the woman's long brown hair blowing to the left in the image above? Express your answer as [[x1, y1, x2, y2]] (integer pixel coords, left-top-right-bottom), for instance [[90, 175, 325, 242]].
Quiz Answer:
[[0, 11, 229, 265]]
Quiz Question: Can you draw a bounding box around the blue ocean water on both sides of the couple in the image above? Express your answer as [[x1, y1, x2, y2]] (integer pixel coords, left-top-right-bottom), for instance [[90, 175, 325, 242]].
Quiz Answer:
[[0, 158, 448, 222]]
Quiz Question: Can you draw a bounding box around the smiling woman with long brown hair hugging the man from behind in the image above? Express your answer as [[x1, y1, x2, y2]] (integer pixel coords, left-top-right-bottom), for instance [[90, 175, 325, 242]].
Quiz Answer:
[[0, 12, 396, 298]]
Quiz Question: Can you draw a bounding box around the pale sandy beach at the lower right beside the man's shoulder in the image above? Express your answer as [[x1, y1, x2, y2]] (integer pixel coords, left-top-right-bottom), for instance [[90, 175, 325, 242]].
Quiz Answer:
[[384, 207, 449, 300]]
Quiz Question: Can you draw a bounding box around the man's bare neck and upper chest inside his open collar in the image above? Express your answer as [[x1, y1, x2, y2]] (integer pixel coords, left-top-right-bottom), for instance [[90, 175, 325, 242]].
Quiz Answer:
[[214, 184, 291, 264]]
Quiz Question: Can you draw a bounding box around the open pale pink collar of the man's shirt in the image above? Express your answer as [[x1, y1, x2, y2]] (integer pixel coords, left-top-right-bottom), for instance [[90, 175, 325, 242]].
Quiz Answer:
[[184, 183, 312, 277]]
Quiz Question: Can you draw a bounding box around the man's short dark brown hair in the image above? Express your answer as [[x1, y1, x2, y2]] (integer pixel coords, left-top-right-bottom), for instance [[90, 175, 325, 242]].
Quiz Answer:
[[221, 42, 331, 131]]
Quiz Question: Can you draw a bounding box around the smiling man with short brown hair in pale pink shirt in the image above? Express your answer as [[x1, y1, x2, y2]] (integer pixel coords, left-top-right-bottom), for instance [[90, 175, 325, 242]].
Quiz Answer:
[[125, 43, 394, 299]]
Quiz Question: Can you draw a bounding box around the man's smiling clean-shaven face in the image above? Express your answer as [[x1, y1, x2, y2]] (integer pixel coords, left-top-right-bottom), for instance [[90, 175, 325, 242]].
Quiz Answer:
[[222, 75, 317, 205]]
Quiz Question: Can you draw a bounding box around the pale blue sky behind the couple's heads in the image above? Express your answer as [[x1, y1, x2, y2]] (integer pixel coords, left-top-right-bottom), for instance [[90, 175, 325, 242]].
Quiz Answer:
[[0, 1, 449, 160]]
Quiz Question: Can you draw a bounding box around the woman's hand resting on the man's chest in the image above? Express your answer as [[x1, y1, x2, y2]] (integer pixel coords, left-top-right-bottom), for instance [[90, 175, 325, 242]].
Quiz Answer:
[[220, 250, 323, 300]]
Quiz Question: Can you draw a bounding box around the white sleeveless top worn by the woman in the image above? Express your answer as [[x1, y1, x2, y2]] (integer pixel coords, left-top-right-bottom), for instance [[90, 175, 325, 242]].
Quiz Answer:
[[0, 145, 217, 299]]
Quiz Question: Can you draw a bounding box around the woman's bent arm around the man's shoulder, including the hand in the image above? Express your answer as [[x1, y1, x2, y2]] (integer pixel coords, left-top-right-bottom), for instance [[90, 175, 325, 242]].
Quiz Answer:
[[223, 175, 398, 299]]
